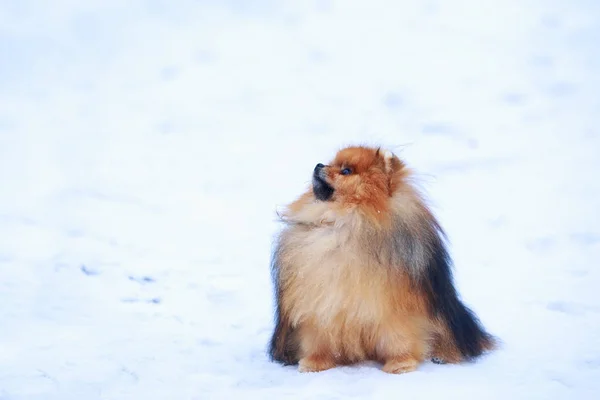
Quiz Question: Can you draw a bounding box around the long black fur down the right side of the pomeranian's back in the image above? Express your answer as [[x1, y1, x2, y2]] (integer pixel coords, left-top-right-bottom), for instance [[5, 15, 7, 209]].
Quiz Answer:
[[419, 222, 494, 361]]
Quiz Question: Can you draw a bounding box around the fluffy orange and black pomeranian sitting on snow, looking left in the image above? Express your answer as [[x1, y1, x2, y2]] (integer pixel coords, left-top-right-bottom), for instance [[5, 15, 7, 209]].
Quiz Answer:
[[269, 146, 496, 373]]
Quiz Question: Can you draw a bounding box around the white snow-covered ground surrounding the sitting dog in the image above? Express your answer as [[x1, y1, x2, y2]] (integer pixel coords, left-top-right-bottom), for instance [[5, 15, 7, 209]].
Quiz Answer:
[[0, 0, 600, 400]]
